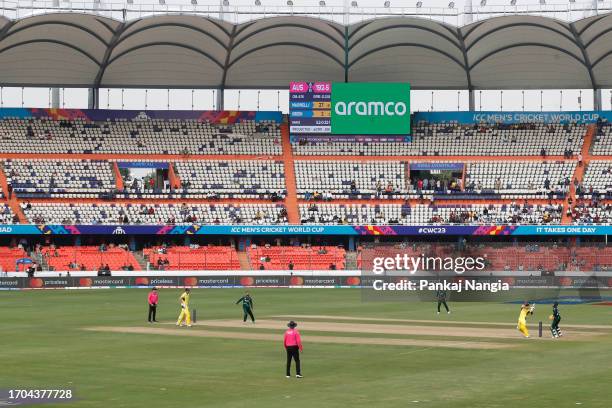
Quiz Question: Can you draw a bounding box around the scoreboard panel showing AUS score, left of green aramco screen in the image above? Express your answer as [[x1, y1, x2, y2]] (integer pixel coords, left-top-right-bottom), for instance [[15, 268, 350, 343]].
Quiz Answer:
[[289, 82, 331, 134]]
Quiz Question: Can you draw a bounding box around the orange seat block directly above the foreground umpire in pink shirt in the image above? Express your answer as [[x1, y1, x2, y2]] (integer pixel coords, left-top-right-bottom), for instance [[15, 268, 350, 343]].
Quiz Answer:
[[247, 246, 346, 270]]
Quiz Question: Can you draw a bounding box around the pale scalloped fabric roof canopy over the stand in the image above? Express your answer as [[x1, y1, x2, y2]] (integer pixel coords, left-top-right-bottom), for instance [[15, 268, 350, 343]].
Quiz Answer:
[[0, 13, 612, 89]]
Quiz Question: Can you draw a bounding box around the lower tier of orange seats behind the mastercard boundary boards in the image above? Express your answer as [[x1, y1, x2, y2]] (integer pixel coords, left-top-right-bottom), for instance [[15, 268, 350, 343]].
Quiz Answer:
[[7, 239, 612, 274]]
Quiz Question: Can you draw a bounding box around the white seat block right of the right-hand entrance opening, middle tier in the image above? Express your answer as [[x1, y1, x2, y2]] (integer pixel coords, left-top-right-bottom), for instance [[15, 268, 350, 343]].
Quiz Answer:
[[465, 161, 576, 198]]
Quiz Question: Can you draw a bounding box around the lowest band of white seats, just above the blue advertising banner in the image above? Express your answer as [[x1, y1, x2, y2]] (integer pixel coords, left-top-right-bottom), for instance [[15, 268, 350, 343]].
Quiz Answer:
[[9, 202, 612, 225]]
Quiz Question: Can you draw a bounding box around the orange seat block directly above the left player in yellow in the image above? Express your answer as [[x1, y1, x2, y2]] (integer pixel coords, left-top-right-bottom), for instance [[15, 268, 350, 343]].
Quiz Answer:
[[143, 246, 240, 270]]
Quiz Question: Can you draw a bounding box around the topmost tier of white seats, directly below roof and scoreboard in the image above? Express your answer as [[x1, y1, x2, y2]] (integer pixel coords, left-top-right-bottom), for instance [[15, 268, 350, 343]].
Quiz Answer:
[[0, 118, 588, 156]]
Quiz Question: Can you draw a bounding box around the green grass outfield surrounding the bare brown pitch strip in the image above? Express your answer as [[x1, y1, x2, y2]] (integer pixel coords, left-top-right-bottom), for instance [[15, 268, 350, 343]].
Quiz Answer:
[[0, 289, 612, 408]]
